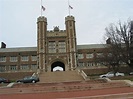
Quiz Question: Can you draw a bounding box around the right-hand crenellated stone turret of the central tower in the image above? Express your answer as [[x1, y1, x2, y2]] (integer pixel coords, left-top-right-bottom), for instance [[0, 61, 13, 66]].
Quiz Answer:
[[65, 16, 77, 70]]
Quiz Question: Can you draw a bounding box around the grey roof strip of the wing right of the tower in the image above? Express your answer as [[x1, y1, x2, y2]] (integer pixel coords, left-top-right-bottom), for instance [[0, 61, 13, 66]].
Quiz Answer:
[[77, 44, 108, 49]]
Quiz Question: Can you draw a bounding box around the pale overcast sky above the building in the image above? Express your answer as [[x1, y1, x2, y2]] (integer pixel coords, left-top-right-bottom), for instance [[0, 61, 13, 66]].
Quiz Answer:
[[0, 0, 133, 47]]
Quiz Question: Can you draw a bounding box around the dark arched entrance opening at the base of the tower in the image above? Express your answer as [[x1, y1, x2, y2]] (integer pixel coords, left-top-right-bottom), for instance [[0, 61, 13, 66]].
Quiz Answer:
[[51, 61, 65, 72]]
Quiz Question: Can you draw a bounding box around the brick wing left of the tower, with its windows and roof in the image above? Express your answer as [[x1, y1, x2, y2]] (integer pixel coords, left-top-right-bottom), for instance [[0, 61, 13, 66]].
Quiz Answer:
[[0, 47, 38, 72]]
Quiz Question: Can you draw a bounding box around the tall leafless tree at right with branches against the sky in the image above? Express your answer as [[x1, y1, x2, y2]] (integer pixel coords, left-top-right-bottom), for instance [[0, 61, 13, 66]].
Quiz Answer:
[[105, 21, 133, 71]]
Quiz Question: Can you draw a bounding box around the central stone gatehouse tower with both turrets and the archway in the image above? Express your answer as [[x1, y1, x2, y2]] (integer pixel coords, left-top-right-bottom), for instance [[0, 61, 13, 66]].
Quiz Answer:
[[37, 16, 77, 72]]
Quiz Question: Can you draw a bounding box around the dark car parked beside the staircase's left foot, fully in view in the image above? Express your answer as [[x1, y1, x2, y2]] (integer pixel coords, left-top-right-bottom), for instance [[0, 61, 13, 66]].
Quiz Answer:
[[17, 76, 39, 83]]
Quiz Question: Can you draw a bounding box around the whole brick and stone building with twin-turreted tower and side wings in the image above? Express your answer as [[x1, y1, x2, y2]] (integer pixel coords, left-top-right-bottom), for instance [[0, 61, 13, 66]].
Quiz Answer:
[[0, 16, 133, 72]]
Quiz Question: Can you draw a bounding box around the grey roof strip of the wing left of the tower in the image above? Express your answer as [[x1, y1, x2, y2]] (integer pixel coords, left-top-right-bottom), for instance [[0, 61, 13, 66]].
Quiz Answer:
[[0, 47, 37, 52]]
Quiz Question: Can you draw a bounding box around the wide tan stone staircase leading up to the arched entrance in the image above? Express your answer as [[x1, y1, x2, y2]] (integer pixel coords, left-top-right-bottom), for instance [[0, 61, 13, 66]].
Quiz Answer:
[[39, 71, 84, 83]]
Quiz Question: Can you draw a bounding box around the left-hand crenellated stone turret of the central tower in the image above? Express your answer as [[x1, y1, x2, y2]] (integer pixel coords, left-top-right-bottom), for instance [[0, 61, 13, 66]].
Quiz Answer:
[[37, 16, 47, 70]]
